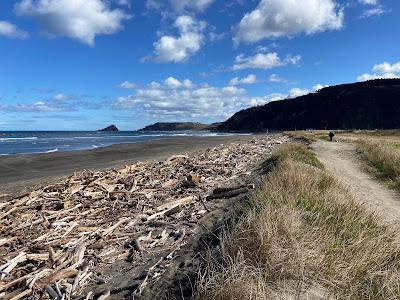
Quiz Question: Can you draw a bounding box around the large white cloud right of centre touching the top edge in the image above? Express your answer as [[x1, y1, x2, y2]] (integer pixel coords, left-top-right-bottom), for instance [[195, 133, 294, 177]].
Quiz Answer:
[[234, 0, 344, 43]]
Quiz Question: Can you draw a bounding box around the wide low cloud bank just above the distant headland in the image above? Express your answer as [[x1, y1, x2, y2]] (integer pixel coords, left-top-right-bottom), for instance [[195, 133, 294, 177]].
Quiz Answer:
[[113, 77, 252, 120]]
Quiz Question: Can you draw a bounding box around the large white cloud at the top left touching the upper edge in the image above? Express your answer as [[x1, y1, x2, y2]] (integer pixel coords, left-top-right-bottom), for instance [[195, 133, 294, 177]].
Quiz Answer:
[[15, 0, 130, 46]]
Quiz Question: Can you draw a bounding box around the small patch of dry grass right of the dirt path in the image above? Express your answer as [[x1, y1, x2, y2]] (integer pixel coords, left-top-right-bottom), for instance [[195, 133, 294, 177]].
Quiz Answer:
[[356, 139, 400, 190]]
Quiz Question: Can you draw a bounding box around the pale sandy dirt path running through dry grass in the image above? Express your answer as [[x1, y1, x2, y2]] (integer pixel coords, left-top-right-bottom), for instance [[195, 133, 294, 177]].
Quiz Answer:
[[313, 141, 400, 231]]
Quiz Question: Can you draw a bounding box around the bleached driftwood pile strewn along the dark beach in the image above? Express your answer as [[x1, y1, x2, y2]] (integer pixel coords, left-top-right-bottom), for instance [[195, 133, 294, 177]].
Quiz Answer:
[[0, 136, 286, 299]]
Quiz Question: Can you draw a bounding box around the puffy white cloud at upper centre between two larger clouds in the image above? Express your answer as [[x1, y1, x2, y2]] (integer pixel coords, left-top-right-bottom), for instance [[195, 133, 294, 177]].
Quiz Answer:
[[154, 15, 206, 62]]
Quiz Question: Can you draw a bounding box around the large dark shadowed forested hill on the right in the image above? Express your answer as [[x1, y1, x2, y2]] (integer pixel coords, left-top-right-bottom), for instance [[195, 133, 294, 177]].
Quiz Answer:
[[218, 79, 400, 131]]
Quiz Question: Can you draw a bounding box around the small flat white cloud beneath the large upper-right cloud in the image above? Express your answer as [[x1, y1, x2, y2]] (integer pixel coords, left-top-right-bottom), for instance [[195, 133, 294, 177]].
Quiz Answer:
[[233, 52, 301, 70]]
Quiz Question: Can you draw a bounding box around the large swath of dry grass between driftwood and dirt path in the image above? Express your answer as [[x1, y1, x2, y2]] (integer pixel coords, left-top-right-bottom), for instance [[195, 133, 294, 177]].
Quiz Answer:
[[195, 144, 400, 300]]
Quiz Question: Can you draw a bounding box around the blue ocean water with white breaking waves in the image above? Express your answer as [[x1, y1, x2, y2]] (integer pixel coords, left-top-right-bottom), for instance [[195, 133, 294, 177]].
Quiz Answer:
[[0, 131, 234, 155]]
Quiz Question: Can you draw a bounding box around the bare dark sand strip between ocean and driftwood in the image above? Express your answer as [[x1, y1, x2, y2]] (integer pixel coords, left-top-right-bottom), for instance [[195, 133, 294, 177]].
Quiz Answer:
[[0, 135, 252, 195]]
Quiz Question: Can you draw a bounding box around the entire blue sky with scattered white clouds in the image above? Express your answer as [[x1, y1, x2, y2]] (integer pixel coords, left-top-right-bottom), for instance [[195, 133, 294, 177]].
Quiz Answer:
[[0, 0, 400, 131]]
